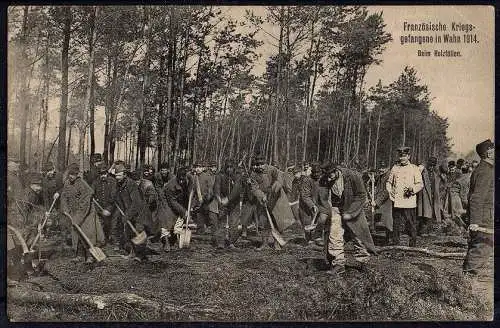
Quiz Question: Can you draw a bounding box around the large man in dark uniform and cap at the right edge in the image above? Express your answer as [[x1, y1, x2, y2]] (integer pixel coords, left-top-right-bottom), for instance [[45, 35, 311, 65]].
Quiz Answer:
[[463, 139, 495, 275]]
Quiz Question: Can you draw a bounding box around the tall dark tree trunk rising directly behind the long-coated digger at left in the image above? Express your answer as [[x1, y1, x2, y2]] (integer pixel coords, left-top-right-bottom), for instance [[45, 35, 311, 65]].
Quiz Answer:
[[57, 7, 72, 171]]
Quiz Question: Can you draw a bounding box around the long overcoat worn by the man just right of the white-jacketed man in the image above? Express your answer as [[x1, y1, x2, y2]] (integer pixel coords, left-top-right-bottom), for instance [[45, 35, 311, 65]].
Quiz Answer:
[[417, 168, 442, 222]]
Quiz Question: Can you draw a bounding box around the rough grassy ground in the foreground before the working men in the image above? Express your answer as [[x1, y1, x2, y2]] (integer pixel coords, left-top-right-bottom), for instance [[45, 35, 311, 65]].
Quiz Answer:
[[7, 223, 493, 321]]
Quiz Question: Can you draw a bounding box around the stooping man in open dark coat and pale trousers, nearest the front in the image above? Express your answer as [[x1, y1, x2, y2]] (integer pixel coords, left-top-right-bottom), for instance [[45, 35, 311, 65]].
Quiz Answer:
[[323, 164, 377, 274]]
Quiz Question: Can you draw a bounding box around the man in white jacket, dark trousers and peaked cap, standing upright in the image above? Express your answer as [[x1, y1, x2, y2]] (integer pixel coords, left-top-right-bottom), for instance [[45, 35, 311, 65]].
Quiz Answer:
[[386, 147, 424, 247]]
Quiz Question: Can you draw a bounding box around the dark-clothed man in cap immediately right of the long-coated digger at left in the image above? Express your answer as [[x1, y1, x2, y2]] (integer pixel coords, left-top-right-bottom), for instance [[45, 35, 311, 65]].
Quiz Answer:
[[92, 162, 121, 250]]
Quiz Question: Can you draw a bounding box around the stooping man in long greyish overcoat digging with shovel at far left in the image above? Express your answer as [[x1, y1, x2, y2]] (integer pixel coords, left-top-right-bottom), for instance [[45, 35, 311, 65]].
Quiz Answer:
[[61, 163, 105, 262]]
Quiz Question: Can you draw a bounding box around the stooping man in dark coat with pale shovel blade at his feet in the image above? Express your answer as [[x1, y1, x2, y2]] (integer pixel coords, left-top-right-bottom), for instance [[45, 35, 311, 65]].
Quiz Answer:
[[160, 167, 194, 246]]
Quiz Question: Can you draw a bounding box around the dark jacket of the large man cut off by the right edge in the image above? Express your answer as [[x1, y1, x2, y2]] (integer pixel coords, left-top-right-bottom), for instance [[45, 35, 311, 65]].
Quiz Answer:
[[468, 160, 495, 229]]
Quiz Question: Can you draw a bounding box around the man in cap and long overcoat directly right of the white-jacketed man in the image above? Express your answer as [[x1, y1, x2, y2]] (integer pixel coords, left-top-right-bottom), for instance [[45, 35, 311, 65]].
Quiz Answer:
[[417, 157, 441, 235]]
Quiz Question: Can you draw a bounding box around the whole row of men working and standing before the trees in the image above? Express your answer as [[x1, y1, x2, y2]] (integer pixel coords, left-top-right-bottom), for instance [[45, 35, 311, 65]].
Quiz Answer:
[[5, 140, 494, 274]]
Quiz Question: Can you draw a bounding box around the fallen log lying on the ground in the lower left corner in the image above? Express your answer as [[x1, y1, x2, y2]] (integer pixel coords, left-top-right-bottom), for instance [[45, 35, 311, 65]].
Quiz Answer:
[[8, 285, 161, 315]]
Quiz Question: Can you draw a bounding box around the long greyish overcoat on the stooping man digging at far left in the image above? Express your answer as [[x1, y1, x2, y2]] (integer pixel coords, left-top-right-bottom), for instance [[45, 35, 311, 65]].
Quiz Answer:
[[61, 177, 105, 251]]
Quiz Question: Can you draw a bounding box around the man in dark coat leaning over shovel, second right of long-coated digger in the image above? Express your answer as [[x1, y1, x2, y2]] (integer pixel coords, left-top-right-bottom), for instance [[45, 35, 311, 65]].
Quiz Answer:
[[115, 164, 152, 260]]
